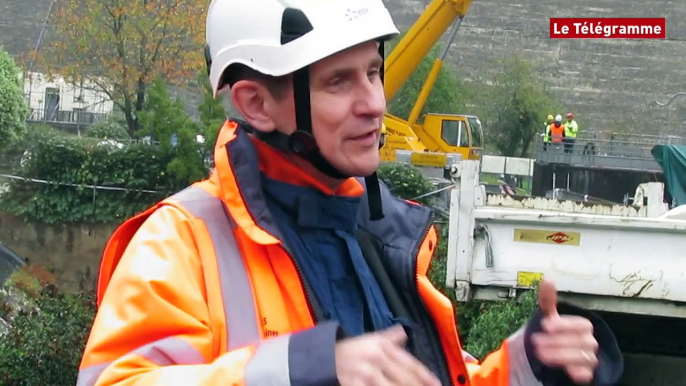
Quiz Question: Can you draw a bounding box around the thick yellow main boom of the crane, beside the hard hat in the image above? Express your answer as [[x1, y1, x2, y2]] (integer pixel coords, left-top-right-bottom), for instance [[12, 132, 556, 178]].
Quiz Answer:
[[384, 0, 472, 100]]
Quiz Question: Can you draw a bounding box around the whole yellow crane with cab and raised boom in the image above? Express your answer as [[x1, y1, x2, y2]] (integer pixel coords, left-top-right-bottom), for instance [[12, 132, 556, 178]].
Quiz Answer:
[[380, 0, 483, 166]]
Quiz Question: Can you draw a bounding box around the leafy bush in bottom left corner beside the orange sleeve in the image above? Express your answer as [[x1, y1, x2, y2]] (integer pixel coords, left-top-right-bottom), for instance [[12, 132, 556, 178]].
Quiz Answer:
[[0, 271, 95, 386]]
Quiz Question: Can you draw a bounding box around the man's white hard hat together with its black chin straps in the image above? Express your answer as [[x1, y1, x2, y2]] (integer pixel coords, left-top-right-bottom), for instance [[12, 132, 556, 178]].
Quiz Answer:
[[205, 0, 400, 220]]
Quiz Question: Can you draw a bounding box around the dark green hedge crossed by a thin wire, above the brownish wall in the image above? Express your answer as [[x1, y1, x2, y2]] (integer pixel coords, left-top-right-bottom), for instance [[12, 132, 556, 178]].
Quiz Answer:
[[0, 126, 186, 223]]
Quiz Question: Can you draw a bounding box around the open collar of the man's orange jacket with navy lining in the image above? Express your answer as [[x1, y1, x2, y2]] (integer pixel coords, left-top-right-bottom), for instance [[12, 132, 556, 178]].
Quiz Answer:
[[210, 121, 432, 250]]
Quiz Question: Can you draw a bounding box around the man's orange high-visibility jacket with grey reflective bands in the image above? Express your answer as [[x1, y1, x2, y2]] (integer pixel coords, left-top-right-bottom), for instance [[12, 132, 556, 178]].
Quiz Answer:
[[78, 122, 620, 386]]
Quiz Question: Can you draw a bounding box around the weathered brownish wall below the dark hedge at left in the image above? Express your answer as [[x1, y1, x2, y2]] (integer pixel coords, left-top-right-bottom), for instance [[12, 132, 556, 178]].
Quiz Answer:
[[0, 213, 115, 290]]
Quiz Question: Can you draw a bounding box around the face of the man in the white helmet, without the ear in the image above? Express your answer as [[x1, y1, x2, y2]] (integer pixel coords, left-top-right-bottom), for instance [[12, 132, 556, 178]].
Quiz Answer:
[[271, 42, 386, 176]]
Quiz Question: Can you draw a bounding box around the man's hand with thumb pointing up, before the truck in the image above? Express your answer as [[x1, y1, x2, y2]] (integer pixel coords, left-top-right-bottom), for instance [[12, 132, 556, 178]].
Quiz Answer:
[[532, 281, 598, 383]]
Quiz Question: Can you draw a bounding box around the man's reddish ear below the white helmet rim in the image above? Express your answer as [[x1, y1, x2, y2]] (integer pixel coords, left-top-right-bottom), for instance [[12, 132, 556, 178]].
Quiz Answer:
[[231, 80, 276, 133]]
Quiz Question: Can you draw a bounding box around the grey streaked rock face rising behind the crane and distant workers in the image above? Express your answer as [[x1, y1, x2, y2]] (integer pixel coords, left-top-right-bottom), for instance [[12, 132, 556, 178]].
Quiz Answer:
[[0, 0, 686, 134]]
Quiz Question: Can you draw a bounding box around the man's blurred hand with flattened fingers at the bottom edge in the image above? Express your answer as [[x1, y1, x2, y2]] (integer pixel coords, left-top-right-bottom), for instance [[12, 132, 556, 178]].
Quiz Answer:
[[336, 326, 441, 386]]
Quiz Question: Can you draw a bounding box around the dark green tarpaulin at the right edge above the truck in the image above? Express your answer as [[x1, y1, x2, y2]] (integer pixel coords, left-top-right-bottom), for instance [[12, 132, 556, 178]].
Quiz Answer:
[[651, 145, 686, 206]]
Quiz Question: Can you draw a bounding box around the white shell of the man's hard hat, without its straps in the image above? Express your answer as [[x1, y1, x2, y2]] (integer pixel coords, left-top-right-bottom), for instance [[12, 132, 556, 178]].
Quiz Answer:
[[206, 0, 399, 96]]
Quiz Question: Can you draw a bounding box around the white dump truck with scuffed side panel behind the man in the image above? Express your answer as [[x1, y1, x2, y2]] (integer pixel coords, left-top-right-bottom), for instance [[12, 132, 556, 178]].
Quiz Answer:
[[445, 161, 686, 386]]
